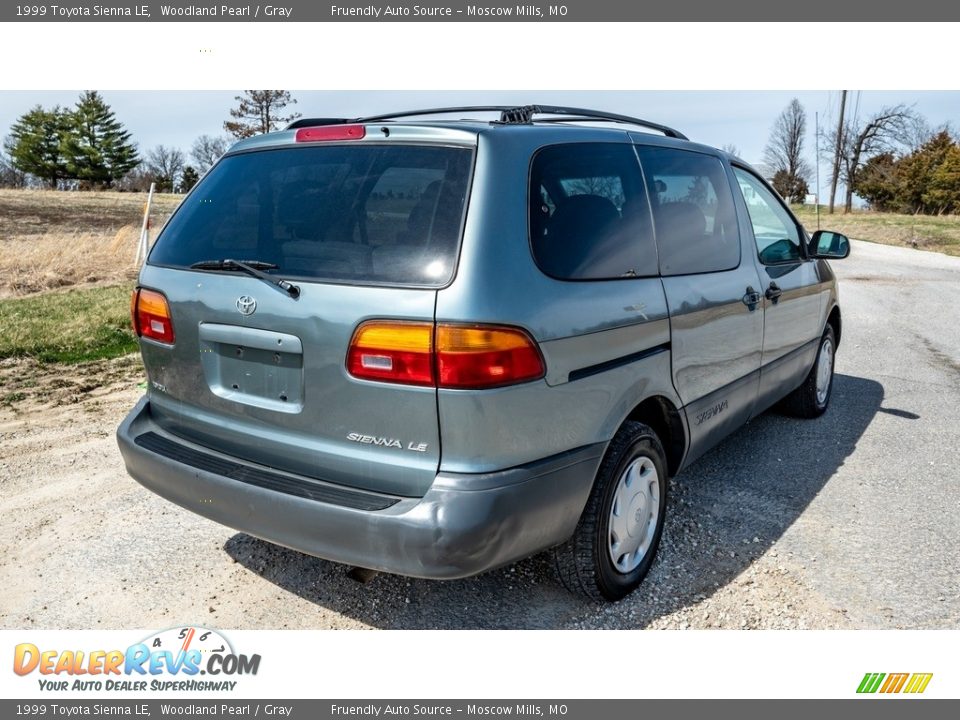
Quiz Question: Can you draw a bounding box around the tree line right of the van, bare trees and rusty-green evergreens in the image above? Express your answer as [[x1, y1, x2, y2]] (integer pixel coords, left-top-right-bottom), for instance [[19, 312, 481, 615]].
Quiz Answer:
[[761, 91, 960, 214]]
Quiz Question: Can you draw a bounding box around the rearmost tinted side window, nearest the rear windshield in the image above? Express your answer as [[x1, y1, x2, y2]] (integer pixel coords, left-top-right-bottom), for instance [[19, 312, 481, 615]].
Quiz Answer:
[[529, 143, 657, 280]]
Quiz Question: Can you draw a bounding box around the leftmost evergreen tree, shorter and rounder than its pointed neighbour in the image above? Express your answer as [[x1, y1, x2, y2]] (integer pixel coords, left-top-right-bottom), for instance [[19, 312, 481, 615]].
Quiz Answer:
[[5, 105, 70, 188]]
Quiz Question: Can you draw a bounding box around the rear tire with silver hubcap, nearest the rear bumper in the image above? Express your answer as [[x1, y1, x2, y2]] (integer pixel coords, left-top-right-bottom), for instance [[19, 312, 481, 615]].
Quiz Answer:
[[553, 421, 667, 600]]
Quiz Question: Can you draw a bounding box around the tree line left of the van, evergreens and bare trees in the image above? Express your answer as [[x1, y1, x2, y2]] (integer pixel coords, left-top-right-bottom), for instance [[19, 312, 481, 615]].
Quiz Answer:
[[0, 90, 300, 192]]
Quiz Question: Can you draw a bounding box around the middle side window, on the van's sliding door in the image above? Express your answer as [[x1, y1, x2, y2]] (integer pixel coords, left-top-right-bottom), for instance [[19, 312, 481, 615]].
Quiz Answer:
[[638, 147, 740, 275]]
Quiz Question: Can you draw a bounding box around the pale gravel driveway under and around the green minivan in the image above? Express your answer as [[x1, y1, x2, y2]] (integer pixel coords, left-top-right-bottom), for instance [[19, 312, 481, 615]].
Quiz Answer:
[[0, 242, 960, 629]]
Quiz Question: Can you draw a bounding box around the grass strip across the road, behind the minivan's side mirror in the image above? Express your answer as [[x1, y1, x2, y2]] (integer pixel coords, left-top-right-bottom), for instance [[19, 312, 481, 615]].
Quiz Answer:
[[793, 205, 960, 255]]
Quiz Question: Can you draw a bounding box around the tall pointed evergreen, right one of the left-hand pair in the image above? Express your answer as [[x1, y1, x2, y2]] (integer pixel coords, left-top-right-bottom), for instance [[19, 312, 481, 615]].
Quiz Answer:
[[63, 90, 140, 187]]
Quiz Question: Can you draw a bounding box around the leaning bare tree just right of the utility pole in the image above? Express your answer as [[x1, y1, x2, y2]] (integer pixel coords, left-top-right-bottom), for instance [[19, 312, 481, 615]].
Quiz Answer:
[[831, 104, 917, 213]]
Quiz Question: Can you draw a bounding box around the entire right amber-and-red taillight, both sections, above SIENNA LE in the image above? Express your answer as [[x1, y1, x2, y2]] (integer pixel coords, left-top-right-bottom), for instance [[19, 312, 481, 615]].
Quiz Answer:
[[347, 320, 545, 389]]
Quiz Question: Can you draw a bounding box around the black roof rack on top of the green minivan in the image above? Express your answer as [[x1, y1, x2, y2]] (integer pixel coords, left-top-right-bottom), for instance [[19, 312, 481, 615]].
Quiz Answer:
[[286, 105, 689, 140]]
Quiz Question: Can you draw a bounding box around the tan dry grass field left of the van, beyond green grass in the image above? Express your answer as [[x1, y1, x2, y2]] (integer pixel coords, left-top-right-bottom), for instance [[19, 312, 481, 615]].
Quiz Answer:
[[0, 190, 182, 297]]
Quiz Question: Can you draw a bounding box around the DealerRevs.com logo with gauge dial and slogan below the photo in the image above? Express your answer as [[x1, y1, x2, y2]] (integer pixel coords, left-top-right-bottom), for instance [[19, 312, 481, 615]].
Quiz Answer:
[[13, 627, 260, 692]]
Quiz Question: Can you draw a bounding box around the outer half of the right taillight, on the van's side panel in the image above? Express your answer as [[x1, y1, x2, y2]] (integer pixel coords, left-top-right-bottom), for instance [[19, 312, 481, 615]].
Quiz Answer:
[[437, 324, 544, 389]]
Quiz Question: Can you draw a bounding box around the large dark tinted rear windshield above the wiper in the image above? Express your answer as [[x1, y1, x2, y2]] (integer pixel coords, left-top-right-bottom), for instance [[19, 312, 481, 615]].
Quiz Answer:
[[150, 145, 473, 286]]
